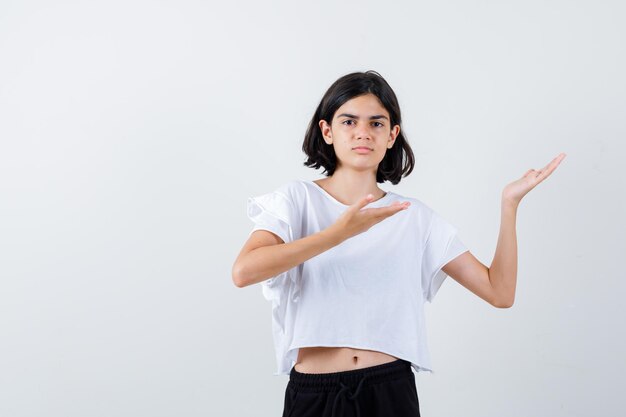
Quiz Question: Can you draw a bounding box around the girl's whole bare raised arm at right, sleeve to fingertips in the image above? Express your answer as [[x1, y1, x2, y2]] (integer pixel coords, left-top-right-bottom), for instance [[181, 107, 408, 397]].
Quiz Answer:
[[441, 153, 565, 308]]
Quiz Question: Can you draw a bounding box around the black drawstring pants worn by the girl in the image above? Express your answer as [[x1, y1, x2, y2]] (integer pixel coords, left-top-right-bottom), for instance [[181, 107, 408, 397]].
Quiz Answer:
[[282, 359, 420, 417]]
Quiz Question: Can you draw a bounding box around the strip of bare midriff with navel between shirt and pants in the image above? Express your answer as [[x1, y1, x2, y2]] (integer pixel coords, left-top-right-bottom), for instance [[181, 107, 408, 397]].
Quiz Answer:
[[295, 346, 398, 374]]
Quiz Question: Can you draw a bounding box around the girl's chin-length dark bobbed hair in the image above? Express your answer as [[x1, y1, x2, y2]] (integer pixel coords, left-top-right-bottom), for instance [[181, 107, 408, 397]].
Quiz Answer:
[[302, 70, 415, 185]]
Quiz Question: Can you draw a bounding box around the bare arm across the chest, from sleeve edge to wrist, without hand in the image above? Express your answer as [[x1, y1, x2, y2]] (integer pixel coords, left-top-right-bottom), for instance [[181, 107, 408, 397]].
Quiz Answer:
[[232, 226, 345, 288]]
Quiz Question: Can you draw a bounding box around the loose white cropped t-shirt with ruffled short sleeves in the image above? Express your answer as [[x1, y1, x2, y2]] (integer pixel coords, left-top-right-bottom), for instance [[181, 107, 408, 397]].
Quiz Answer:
[[247, 180, 468, 375]]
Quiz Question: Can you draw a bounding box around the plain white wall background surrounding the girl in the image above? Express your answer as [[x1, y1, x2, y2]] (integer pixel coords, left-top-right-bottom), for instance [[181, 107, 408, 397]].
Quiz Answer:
[[0, 0, 626, 417]]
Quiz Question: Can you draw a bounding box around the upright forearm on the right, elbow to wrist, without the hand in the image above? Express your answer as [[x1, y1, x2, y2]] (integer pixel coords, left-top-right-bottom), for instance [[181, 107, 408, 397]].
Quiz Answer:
[[489, 199, 518, 307]]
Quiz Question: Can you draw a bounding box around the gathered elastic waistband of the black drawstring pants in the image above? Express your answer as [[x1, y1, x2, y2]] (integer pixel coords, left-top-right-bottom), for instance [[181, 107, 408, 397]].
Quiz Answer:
[[288, 359, 413, 392]]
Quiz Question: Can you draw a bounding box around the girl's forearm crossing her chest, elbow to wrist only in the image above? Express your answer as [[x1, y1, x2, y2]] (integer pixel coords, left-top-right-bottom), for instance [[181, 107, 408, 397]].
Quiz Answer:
[[238, 226, 345, 287]]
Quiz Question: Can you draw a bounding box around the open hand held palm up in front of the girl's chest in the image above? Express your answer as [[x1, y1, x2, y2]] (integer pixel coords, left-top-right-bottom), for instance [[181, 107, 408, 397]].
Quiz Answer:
[[330, 197, 411, 241]]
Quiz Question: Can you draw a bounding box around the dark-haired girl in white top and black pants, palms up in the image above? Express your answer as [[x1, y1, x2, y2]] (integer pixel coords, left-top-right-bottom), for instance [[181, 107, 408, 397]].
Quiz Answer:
[[233, 71, 565, 417]]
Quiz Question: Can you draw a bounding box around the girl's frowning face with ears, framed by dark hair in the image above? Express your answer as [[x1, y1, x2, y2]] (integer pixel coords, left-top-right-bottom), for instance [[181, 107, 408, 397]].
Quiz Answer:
[[319, 94, 400, 173]]
